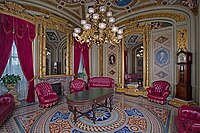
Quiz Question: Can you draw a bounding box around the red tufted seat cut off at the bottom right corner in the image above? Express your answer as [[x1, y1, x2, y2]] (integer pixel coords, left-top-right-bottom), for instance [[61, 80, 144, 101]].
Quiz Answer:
[[175, 105, 200, 133]]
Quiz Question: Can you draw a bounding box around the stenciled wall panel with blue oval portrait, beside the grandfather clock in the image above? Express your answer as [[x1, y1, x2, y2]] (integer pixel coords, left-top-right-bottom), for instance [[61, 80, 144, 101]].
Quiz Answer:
[[152, 30, 173, 83]]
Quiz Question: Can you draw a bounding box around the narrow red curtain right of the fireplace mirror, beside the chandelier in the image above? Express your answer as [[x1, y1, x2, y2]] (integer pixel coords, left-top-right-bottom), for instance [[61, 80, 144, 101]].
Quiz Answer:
[[74, 38, 82, 77]]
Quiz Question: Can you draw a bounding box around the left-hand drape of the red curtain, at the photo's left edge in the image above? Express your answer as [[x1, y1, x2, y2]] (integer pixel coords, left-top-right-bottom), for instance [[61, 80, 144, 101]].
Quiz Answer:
[[0, 14, 14, 77]]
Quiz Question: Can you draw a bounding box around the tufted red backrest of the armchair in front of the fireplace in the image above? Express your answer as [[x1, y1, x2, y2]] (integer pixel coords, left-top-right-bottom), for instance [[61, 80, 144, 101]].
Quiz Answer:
[[35, 82, 55, 96]]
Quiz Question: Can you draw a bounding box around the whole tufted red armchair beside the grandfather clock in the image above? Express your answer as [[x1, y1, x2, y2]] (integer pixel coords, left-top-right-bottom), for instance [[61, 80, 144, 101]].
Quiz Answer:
[[147, 80, 171, 104]]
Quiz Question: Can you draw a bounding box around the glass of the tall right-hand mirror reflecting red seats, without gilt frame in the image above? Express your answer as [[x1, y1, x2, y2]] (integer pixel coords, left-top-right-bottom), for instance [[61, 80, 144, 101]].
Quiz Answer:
[[124, 34, 144, 86]]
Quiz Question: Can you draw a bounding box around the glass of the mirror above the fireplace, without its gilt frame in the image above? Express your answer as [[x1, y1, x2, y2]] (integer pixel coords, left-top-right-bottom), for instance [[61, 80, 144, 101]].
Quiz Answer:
[[46, 29, 67, 75]]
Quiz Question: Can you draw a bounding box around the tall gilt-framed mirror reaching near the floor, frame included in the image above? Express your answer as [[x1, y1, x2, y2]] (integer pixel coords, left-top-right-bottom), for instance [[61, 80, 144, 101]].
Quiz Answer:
[[121, 22, 150, 87]]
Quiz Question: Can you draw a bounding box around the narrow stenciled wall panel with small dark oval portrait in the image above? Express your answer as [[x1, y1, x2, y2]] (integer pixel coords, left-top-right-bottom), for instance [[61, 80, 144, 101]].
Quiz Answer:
[[106, 44, 118, 82]]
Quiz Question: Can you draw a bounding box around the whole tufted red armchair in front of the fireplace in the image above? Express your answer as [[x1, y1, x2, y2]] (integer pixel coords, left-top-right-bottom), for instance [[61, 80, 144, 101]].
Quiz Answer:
[[35, 82, 58, 107]]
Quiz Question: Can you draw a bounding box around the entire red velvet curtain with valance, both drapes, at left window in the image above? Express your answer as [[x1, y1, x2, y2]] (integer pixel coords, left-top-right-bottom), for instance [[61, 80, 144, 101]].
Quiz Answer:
[[0, 14, 35, 102]]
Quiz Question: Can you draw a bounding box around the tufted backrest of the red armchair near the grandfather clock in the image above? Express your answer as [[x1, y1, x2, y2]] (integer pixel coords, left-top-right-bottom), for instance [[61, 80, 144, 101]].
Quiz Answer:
[[152, 80, 170, 92]]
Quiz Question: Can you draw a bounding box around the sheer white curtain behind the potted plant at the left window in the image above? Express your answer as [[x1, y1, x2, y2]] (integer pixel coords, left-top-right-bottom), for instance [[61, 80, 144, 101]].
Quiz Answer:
[[2, 42, 28, 100]]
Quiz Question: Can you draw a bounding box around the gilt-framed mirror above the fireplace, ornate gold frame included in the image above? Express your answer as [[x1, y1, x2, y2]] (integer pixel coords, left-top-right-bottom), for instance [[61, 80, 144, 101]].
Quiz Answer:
[[37, 15, 73, 77]]
